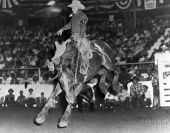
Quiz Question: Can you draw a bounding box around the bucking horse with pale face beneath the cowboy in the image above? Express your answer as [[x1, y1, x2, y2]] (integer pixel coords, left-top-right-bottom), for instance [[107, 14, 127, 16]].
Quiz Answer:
[[35, 40, 115, 128]]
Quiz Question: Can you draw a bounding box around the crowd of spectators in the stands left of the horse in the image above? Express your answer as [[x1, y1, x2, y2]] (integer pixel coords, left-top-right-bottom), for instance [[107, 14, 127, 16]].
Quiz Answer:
[[0, 26, 56, 84]]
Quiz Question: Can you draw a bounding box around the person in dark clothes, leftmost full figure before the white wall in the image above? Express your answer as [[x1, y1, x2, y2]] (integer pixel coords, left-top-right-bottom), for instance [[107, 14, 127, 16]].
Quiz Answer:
[[4, 89, 15, 107]]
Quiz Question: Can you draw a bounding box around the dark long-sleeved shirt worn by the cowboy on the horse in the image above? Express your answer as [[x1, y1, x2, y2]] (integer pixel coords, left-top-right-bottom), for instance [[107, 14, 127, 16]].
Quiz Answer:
[[62, 10, 88, 38]]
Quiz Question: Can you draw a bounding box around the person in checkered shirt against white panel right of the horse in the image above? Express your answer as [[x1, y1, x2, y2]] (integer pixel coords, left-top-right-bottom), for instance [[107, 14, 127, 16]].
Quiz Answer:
[[130, 77, 143, 108]]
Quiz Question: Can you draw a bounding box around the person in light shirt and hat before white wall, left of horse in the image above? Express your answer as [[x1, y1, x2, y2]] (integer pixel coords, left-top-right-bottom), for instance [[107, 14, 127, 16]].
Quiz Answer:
[[26, 89, 35, 107]]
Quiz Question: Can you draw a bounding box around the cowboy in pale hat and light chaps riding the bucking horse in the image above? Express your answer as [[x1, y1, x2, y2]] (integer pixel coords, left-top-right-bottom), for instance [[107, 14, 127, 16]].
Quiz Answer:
[[47, 0, 92, 75]]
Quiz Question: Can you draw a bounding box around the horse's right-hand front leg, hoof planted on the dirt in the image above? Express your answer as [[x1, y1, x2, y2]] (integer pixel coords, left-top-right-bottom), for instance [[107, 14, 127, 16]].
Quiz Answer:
[[58, 74, 82, 128]]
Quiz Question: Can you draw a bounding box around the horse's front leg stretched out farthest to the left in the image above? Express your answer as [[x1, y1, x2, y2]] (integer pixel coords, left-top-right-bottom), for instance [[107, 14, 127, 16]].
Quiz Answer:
[[35, 83, 62, 125]]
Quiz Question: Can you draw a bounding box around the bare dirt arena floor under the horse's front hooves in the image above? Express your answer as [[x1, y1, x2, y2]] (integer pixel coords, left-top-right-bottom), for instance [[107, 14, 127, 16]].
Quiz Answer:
[[0, 108, 170, 133]]
